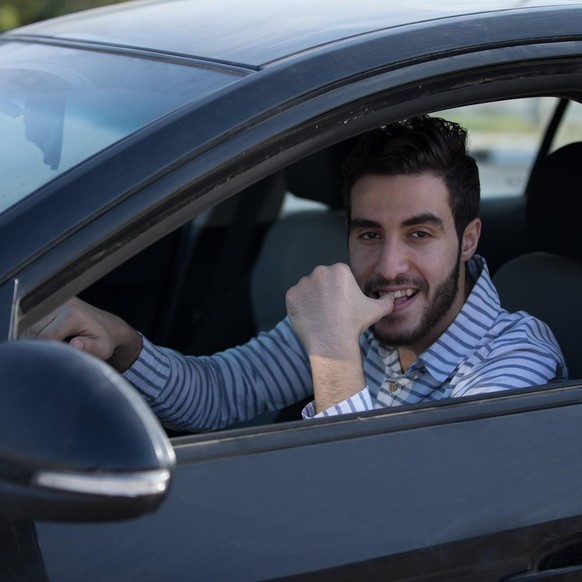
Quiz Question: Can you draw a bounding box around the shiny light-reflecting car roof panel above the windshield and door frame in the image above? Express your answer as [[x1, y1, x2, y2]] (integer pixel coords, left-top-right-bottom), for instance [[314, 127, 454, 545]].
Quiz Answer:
[[7, 0, 582, 69]]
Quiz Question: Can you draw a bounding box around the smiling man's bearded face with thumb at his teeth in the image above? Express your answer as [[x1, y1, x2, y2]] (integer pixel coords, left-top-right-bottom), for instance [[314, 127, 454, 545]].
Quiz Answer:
[[349, 173, 479, 354]]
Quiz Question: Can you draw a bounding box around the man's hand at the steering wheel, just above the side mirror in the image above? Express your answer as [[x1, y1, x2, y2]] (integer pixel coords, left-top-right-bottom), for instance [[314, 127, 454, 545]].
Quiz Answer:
[[25, 298, 142, 372]]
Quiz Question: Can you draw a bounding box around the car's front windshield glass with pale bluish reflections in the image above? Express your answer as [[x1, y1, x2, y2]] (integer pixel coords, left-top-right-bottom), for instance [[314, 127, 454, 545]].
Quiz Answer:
[[0, 42, 242, 213]]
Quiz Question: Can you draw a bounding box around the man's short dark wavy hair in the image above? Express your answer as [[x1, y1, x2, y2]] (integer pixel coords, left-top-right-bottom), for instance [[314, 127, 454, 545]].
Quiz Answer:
[[342, 115, 480, 239]]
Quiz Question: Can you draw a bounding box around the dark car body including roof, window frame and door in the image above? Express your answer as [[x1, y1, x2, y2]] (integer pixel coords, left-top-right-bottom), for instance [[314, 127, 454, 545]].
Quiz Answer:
[[0, 0, 582, 582]]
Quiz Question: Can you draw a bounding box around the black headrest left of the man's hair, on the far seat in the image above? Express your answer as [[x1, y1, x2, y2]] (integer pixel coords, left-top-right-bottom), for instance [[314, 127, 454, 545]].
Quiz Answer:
[[285, 138, 359, 210]]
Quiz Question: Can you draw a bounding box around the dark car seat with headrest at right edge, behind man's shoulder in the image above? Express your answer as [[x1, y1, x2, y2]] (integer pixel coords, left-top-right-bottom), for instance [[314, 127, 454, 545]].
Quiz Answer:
[[493, 142, 582, 378]]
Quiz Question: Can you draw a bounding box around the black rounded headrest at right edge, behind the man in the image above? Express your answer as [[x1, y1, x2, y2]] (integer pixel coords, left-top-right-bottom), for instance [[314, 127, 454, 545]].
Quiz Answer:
[[526, 142, 582, 259]]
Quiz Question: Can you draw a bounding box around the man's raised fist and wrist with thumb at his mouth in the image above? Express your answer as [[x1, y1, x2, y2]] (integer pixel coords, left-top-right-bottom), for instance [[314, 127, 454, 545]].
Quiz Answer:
[[286, 263, 394, 412]]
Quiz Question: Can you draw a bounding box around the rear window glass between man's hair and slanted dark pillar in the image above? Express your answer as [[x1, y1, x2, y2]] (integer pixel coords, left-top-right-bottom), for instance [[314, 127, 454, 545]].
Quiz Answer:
[[436, 97, 558, 198]]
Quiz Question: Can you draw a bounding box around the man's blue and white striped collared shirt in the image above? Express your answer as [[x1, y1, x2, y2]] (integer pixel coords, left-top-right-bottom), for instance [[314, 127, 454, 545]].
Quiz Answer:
[[125, 256, 566, 430]]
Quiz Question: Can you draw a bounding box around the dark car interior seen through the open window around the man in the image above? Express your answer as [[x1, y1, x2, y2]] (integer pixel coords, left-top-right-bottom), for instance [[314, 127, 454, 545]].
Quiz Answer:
[[76, 97, 582, 432]]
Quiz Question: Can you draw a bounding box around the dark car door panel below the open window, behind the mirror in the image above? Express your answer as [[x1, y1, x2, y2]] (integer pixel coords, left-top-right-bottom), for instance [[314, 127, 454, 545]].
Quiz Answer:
[[21, 383, 582, 582]]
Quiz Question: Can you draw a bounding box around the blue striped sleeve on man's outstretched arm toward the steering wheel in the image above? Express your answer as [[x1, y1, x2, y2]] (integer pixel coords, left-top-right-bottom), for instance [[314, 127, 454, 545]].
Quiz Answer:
[[124, 319, 312, 431]]
